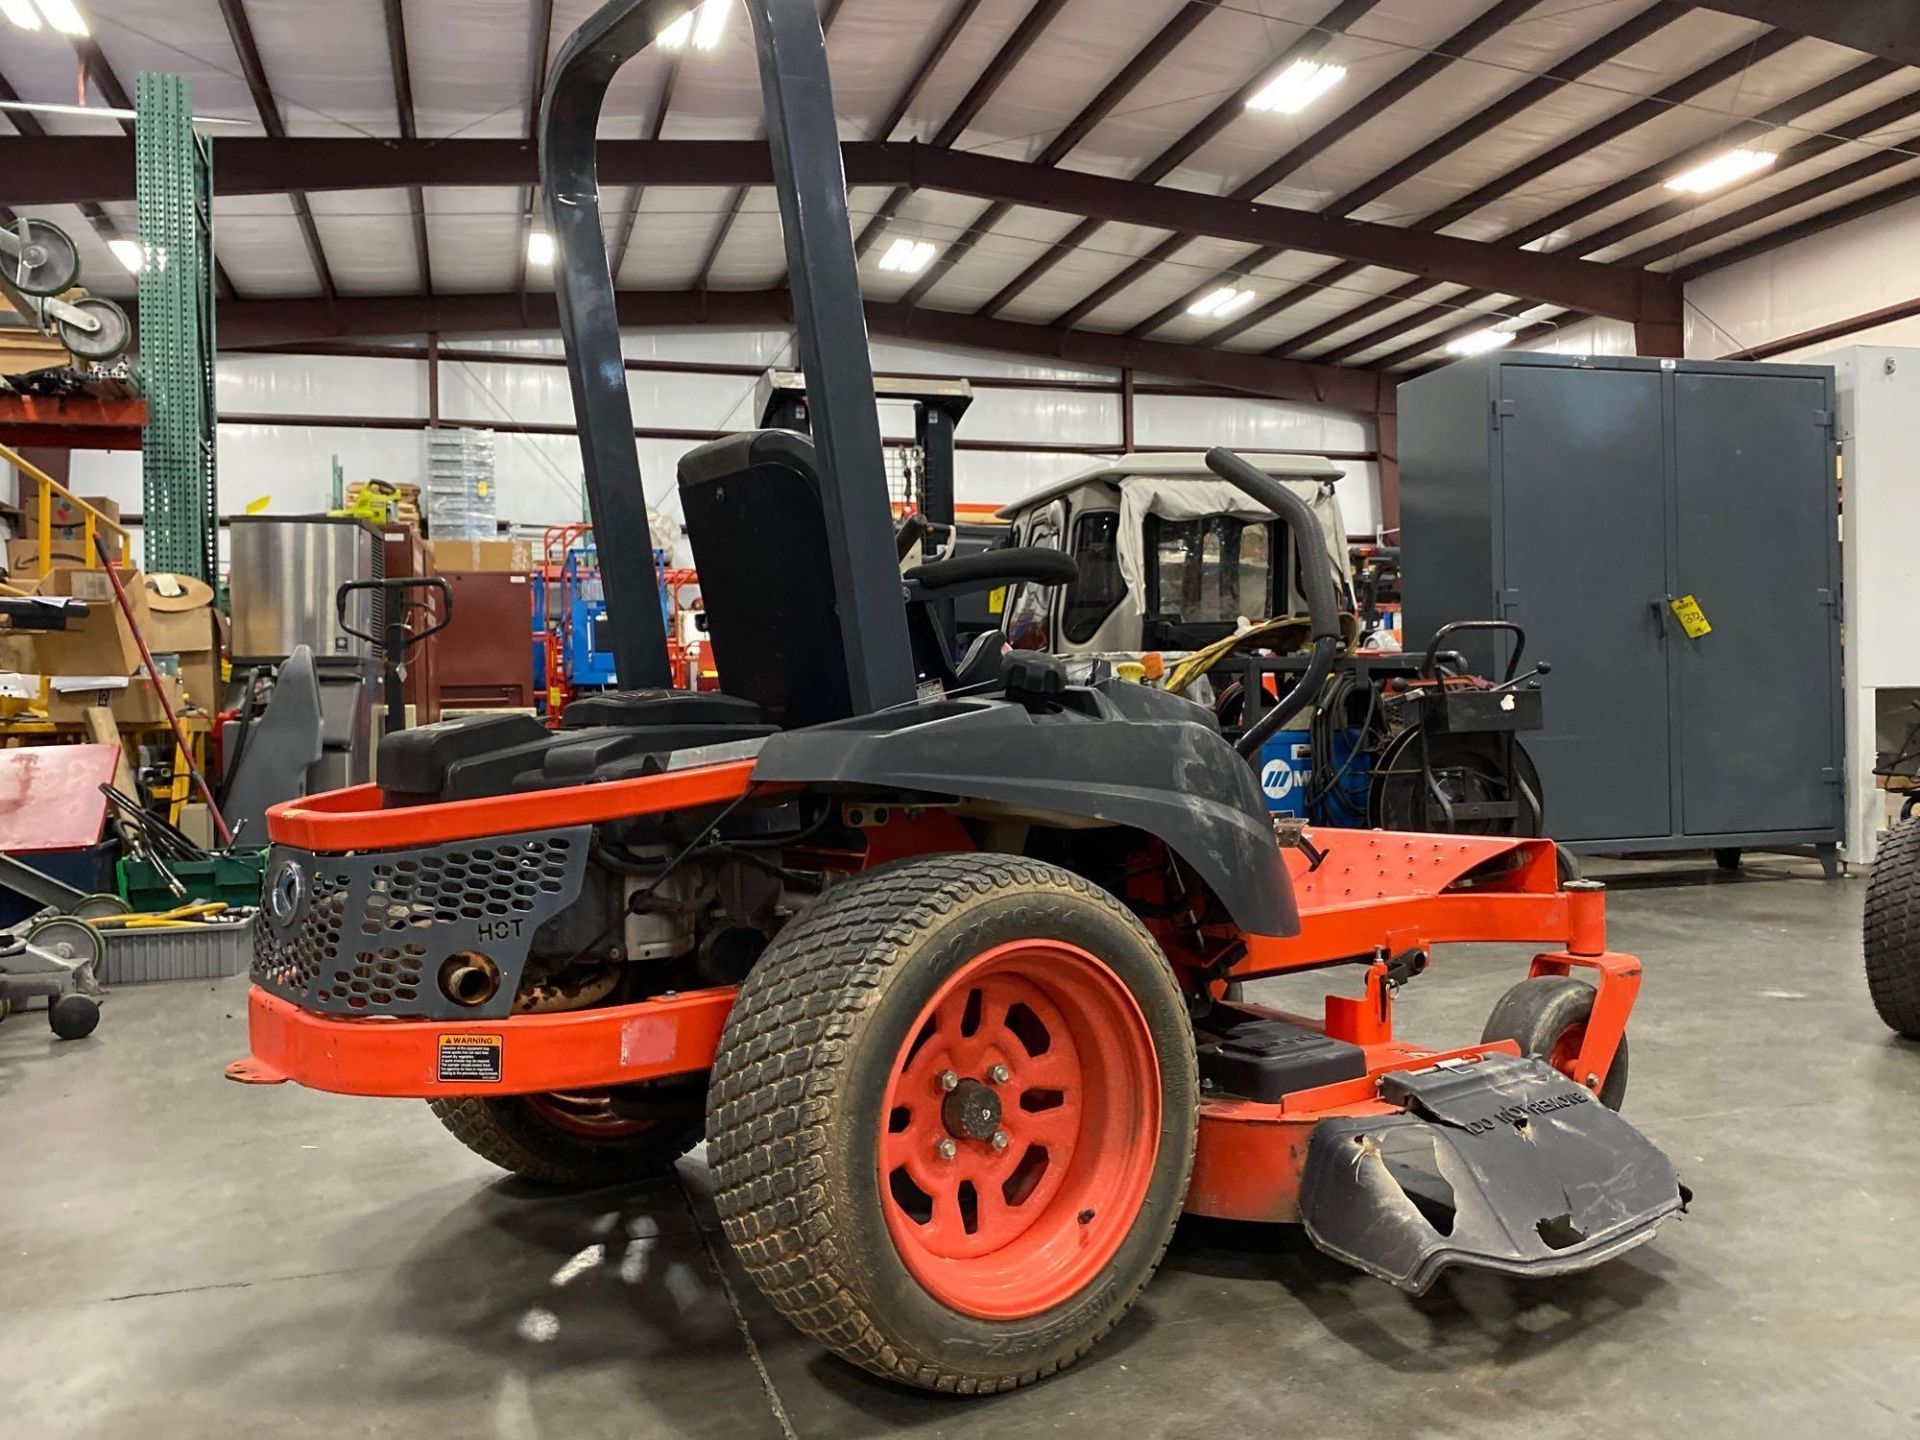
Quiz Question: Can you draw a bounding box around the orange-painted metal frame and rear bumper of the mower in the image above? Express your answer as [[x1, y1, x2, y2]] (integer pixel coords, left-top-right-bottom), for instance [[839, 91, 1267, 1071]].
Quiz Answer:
[[227, 760, 1640, 1221]]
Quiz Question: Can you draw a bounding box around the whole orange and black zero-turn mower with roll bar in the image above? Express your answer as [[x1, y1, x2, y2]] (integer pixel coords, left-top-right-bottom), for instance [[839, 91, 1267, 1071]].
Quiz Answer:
[[228, 0, 1684, 1392]]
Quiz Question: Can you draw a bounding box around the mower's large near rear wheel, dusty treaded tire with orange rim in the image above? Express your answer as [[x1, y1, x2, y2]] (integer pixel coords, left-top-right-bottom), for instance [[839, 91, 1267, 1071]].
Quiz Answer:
[[707, 854, 1198, 1394]]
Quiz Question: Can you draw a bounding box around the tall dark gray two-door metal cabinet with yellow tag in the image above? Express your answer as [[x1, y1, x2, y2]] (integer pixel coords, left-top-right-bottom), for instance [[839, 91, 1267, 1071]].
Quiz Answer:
[[1400, 353, 1843, 864]]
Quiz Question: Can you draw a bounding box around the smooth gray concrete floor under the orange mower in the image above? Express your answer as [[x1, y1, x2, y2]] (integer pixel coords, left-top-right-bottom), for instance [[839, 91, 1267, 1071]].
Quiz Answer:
[[0, 858, 1920, 1440]]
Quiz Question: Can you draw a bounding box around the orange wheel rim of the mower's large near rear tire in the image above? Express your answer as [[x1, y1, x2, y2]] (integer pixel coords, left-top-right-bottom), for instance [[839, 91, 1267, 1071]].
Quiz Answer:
[[879, 941, 1160, 1321]]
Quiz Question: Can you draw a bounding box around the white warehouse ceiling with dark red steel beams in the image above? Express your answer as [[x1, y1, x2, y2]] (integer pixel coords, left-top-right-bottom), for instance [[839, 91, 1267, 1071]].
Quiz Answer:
[[0, 0, 1920, 397]]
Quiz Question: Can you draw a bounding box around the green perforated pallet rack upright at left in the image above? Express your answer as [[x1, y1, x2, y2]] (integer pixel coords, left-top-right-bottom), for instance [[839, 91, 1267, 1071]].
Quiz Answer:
[[134, 71, 221, 582]]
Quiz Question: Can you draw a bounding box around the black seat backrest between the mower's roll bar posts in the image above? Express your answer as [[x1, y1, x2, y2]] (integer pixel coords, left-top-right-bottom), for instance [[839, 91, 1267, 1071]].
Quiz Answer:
[[680, 430, 852, 730]]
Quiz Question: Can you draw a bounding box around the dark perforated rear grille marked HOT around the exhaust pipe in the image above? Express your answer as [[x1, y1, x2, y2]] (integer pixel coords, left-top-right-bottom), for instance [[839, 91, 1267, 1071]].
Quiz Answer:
[[253, 829, 588, 1016]]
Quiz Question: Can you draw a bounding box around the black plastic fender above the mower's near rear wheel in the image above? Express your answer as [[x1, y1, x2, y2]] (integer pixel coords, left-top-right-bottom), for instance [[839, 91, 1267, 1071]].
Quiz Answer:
[[753, 682, 1300, 937]]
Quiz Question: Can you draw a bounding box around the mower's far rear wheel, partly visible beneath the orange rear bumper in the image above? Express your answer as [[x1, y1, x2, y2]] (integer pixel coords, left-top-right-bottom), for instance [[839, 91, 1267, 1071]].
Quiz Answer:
[[426, 1094, 701, 1190]]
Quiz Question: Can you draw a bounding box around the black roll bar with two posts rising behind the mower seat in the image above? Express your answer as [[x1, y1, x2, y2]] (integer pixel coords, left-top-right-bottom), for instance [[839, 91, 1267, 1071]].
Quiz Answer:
[[540, 0, 914, 710]]
